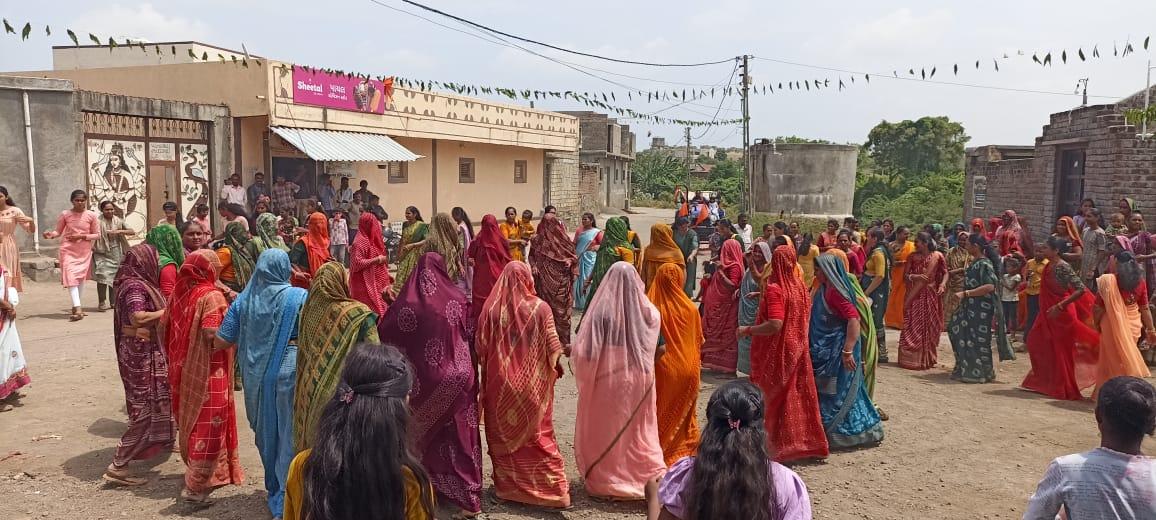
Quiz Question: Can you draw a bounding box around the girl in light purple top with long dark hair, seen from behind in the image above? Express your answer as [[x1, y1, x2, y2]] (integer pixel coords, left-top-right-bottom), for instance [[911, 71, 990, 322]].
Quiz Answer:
[[647, 379, 810, 520]]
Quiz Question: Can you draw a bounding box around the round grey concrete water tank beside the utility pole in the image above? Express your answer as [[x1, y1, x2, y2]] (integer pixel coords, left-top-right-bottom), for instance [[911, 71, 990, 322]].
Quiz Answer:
[[750, 140, 859, 217]]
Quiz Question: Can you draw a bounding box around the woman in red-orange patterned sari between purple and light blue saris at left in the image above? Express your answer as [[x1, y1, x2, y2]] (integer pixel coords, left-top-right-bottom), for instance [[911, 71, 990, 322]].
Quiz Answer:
[[164, 250, 245, 503]]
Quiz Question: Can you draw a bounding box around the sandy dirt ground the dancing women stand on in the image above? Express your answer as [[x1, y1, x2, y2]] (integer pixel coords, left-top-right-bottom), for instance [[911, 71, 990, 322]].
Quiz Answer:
[[0, 206, 1156, 520]]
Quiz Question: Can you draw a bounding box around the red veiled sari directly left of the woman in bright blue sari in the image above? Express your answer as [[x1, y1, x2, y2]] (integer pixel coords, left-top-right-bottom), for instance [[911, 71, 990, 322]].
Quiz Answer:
[[750, 246, 829, 462]]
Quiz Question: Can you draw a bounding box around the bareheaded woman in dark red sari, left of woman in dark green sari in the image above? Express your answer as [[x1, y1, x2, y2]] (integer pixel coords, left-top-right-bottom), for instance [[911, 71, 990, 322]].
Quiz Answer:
[[899, 231, 947, 370]]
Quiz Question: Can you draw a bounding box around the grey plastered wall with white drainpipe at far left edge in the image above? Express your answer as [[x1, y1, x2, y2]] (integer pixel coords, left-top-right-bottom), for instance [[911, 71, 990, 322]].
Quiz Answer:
[[0, 76, 84, 254]]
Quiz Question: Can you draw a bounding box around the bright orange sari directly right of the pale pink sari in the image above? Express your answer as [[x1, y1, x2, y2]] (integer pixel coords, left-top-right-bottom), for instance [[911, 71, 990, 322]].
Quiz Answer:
[[646, 263, 703, 466]]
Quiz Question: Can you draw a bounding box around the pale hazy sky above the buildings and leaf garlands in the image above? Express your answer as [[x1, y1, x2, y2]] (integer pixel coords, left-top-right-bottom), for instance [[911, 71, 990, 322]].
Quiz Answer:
[[0, 0, 1156, 149]]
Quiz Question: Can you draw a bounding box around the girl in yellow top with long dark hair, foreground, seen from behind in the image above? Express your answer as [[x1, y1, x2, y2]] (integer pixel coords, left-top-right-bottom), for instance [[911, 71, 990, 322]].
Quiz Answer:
[[282, 344, 436, 520]]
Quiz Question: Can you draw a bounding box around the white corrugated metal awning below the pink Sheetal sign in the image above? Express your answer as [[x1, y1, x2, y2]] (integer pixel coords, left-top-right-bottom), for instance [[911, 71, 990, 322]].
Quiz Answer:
[[269, 126, 422, 163]]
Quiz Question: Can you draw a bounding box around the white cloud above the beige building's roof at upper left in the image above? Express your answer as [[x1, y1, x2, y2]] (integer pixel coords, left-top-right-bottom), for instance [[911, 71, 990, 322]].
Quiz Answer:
[[71, 3, 213, 43]]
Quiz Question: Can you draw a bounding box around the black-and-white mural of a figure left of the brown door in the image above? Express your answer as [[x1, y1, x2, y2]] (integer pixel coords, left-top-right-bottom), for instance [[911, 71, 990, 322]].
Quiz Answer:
[[86, 139, 148, 231]]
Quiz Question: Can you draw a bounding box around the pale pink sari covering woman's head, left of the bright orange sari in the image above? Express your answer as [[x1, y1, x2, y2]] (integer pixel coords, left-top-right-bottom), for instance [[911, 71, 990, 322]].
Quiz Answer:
[[570, 262, 665, 500]]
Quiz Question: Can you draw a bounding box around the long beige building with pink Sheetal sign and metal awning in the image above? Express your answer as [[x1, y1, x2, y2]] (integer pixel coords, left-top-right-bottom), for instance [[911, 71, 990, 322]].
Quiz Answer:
[[14, 42, 579, 222]]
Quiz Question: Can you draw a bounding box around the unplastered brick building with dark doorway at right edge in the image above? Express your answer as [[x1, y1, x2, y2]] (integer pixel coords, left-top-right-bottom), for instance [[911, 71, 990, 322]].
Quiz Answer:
[[963, 88, 1156, 239]]
